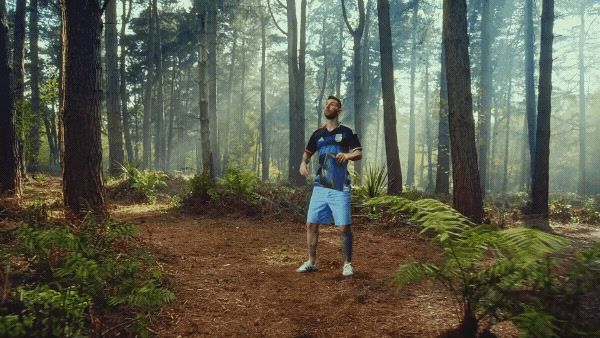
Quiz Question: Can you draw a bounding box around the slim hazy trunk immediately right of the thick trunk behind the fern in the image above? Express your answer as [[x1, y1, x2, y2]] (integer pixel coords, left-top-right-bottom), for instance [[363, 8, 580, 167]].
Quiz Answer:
[[477, 0, 493, 198]]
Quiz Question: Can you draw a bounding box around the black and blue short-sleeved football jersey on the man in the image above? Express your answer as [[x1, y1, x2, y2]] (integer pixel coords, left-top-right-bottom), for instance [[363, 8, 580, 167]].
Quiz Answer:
[[305, 124, 361, 191]]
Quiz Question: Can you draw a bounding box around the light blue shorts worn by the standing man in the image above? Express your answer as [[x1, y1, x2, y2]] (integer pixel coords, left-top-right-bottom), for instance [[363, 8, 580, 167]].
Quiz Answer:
[[306, 186, 352, 226]]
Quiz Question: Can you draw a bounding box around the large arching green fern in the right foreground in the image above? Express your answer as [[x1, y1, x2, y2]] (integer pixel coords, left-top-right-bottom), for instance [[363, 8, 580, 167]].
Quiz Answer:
[[365, 196, 593, 337]]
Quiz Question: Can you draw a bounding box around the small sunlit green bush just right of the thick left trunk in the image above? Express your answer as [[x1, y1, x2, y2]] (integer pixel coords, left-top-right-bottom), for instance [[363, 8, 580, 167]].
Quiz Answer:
[[121, 163, 168, 203]]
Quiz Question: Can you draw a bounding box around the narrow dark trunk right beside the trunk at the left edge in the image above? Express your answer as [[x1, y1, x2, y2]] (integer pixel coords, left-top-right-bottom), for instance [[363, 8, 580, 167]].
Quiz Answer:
[[11, 0, 27, 177]]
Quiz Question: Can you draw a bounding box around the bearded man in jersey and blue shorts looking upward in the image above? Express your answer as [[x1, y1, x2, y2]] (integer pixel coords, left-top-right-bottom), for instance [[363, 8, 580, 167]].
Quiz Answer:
[[296, 96, 362, 277]]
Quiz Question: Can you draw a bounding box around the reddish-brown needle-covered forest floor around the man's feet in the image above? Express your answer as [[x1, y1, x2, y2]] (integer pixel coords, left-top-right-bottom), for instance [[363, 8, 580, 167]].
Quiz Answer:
[[18, 178, 600, 337]]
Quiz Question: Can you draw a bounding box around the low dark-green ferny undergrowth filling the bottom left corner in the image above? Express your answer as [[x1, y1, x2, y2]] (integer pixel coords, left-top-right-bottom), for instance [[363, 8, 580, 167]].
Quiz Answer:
[[0, 222, 175, 337]]
